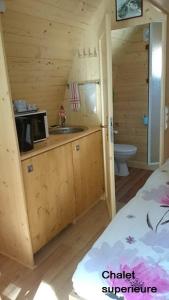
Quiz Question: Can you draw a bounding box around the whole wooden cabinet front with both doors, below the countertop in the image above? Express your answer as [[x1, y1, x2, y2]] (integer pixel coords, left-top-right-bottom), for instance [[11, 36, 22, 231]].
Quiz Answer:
[[22, 131, 104, 253]]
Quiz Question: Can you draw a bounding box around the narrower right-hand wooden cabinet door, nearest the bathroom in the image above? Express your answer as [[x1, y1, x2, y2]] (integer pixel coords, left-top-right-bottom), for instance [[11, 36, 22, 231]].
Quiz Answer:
[[72, 131, 104, 217]]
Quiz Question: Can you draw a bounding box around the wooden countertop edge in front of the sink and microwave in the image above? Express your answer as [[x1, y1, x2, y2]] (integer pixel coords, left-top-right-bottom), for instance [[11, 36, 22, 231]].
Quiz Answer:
[[21, 127, 101, 161]]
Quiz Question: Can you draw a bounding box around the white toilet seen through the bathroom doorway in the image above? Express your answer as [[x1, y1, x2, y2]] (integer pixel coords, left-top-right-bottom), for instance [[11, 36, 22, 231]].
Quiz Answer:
[[114, 144, 137, 176]]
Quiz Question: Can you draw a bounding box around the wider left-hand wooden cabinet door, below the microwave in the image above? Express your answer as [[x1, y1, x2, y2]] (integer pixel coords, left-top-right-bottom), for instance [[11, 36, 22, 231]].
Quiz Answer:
[[22, 144, 75, 252]]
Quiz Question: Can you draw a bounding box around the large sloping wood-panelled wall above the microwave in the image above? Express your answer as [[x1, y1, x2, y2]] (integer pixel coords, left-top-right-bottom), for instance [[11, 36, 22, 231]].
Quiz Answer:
[[3, 0, 101, 124]]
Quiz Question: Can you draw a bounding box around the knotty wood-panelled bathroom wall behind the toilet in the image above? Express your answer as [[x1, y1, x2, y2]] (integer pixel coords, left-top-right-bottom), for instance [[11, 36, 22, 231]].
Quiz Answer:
[[112, 25, 148, 164]]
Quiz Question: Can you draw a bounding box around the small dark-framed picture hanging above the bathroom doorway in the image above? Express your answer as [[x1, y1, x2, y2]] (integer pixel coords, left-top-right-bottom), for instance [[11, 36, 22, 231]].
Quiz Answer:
[[115, 0, 143, 21]]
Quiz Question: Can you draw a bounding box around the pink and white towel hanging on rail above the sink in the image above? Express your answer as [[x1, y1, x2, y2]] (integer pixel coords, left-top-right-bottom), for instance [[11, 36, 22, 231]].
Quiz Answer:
[[69, 82, 80, 112]]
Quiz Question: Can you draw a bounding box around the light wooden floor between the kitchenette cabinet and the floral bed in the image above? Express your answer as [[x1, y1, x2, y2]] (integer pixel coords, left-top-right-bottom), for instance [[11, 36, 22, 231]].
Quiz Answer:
[[0, 201, 109, 300]]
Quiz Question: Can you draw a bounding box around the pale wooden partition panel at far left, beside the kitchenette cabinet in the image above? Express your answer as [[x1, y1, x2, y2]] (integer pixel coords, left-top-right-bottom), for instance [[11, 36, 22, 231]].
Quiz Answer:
[[0, 15, 33, 266]]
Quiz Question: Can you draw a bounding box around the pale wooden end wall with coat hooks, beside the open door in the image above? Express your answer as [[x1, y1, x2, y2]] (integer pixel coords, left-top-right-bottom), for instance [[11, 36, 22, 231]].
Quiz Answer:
[[65, 0, 113, 126]]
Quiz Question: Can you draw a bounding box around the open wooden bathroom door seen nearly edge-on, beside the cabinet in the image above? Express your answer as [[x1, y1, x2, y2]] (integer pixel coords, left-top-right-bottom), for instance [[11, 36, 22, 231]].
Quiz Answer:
[[99, 13, 116, 218]]
